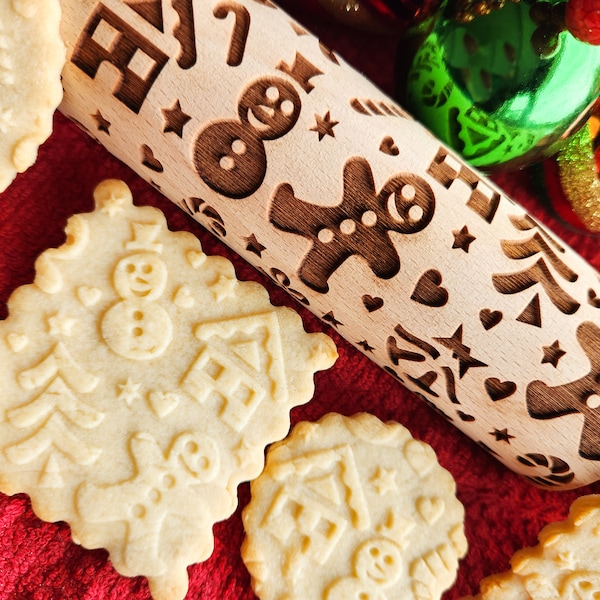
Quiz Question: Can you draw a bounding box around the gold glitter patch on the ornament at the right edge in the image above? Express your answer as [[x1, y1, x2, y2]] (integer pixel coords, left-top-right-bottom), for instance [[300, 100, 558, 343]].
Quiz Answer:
[[557, 116, 600, 232]]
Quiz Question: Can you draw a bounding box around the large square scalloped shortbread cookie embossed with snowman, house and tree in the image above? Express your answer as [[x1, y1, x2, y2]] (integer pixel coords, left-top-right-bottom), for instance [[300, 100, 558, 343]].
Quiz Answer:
[[0, 181, 337, 600]]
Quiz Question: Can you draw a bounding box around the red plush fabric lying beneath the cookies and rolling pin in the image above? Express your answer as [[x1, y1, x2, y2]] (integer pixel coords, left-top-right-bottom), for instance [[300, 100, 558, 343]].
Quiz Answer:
[[0, 0, 600, 600]]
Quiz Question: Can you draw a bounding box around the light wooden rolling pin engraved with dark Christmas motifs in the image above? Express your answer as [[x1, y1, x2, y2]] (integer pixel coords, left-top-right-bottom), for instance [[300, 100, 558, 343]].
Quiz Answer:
[[61, 0, 600, 488]]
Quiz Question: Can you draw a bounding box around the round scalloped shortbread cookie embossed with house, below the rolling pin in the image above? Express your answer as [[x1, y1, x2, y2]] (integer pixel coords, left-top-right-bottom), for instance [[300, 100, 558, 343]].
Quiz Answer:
[[242, 414, 467, 600]]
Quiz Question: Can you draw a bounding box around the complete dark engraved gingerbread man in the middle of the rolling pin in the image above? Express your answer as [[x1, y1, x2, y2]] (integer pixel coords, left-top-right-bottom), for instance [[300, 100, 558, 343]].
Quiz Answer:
[[269, 157, 435, 293]]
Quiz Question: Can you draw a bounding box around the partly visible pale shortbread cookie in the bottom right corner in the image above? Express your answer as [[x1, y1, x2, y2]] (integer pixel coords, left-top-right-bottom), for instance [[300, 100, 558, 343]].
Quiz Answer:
[[463, 495, 600, 600]]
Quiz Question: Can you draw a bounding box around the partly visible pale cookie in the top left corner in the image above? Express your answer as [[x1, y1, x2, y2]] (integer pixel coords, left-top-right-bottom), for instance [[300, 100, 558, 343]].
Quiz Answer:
[[0, 0, 65, 192]]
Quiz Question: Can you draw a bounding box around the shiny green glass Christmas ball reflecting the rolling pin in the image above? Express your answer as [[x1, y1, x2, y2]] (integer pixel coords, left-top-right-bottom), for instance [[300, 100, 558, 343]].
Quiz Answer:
[[398, 0, 600, 172]]
